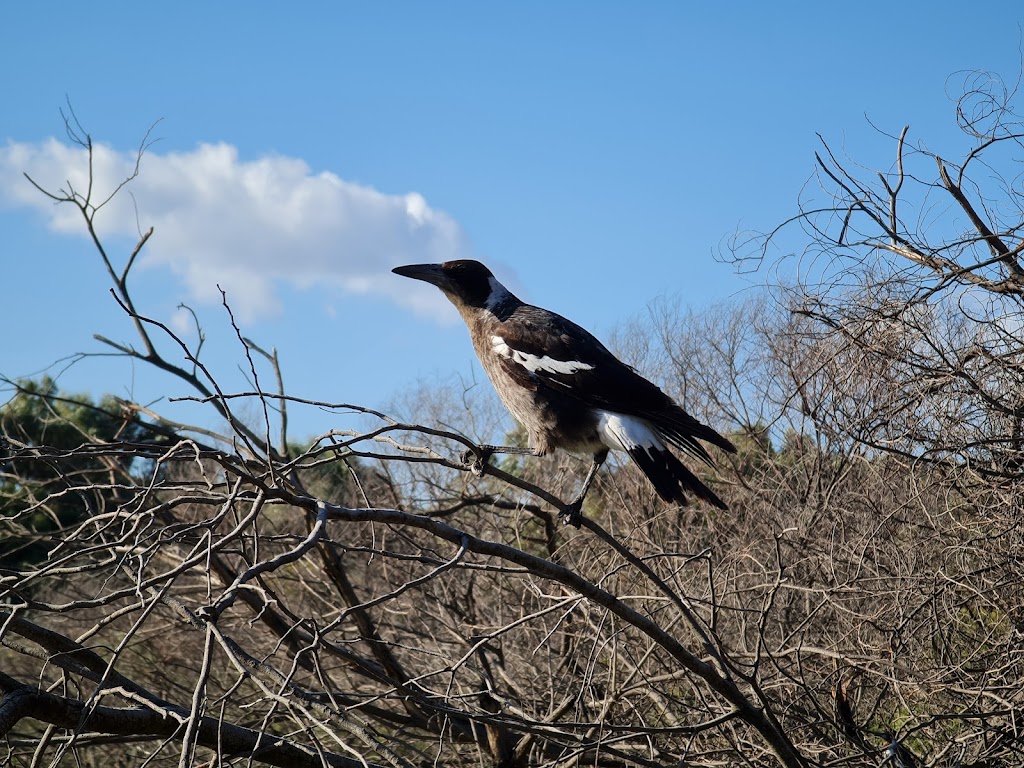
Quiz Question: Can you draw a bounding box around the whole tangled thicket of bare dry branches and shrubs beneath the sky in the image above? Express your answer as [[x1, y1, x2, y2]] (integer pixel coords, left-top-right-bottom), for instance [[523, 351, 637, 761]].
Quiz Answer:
[[0, 77, 1024, 767]]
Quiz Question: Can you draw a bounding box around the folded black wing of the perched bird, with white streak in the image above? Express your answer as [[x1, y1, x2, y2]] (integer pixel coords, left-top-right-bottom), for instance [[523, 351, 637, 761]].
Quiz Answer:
[[493, 304, 735, 464]]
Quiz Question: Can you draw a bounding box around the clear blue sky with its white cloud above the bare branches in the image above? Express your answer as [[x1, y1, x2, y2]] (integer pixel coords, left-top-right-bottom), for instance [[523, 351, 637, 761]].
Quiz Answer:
[[0, 2, 1024, 437]]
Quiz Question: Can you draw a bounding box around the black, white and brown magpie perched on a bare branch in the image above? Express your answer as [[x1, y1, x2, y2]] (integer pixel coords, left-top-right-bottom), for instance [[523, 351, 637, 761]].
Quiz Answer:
[[391, 259, 736, 527]]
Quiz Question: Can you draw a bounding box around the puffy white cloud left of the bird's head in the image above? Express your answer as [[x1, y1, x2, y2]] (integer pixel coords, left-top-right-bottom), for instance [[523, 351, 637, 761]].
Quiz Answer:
[[0, 139, 468, 321]]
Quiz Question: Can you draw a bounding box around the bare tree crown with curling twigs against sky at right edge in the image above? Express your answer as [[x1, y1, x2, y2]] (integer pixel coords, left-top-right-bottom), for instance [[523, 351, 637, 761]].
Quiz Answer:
[[734, 73, 1024, 487]]
